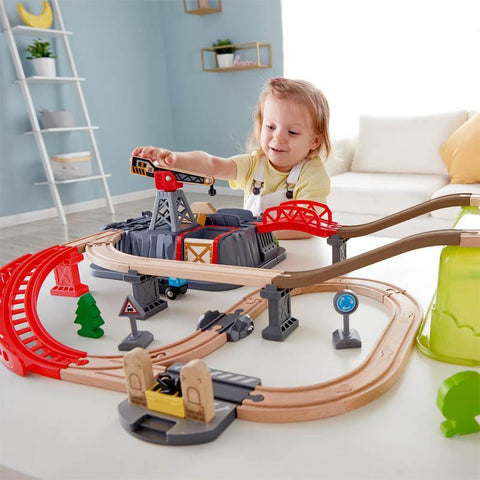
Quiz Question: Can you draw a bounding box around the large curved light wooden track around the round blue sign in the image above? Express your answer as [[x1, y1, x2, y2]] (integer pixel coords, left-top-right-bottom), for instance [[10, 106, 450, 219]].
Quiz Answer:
[[237, 277, 422, 422]]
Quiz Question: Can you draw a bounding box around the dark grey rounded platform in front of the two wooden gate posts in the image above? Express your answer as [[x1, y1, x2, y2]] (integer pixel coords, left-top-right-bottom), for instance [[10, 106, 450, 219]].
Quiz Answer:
[[118, 399, 236, 445]]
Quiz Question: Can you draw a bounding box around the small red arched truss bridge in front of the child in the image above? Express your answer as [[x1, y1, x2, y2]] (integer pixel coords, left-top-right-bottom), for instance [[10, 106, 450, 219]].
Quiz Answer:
[[257, 200, 341, 237]]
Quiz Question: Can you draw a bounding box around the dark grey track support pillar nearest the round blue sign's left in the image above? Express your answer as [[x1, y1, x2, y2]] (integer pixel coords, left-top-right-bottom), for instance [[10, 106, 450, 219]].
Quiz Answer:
[[260, 285, 298, 342]]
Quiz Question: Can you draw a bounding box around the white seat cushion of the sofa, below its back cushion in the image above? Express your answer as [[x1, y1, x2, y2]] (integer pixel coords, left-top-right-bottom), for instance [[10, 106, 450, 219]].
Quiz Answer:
[[327, 172, 449, 216]]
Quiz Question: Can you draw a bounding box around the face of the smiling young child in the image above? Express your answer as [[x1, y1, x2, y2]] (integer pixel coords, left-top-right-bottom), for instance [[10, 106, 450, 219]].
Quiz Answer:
[[260, 95, 320, 172]]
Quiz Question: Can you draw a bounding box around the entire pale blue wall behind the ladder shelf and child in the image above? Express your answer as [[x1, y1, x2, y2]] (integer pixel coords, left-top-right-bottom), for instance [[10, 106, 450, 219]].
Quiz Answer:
[[0, 0, 283, 216]]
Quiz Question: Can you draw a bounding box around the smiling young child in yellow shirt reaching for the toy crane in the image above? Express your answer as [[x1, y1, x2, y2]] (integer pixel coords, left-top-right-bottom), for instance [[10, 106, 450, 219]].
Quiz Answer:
[[132, 78, 330, 217]]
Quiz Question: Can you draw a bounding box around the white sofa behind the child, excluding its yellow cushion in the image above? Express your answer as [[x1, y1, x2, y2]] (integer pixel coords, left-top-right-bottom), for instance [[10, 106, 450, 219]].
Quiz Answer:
[[326, 110, 480, 237]]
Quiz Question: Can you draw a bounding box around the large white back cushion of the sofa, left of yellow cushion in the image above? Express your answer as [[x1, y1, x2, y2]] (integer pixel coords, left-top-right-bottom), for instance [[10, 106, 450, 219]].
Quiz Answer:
[[352, 110, 468, 175]]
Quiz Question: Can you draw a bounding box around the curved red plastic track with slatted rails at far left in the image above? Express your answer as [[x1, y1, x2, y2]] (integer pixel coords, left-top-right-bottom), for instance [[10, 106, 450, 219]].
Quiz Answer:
[[0, 246, 88, 378]]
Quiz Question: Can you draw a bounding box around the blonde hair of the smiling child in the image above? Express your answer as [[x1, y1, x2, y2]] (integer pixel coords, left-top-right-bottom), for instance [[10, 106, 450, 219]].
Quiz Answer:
[[247, 78, 331, 158]]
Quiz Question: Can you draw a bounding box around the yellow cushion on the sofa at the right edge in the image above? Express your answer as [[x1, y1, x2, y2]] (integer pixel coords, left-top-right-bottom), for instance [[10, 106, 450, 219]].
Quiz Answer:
[[440, 113, 480, 183]]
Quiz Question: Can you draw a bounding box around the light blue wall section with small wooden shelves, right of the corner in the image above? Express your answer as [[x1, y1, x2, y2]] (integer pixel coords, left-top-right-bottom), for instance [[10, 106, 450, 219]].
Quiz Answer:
[[162, 0, 283, 155]]
